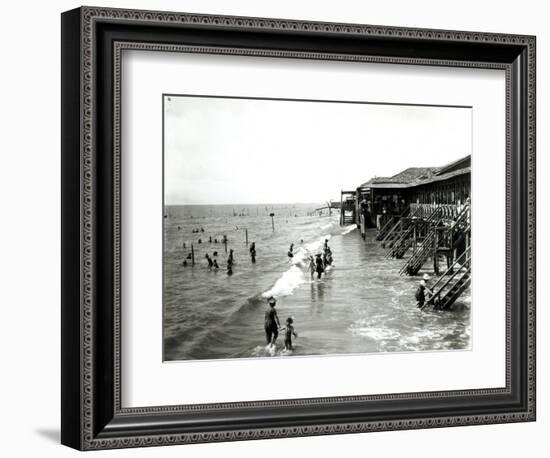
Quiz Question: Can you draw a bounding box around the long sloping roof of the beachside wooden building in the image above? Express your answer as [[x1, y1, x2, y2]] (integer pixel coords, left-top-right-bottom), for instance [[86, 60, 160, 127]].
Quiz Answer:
[[359, 155, 471, 188]]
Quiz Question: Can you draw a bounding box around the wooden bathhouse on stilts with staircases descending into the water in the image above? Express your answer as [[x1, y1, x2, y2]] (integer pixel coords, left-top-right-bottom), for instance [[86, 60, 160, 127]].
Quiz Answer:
[[352, 155, 471, 309]]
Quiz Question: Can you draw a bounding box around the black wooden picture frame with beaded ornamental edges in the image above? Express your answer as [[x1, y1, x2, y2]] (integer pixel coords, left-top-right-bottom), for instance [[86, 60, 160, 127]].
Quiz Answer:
[[61, 7, 535, 450]]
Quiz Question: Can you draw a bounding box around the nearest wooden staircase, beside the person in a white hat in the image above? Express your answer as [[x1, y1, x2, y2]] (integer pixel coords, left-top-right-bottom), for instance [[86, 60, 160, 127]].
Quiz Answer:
[[426, 247, 472, 310]]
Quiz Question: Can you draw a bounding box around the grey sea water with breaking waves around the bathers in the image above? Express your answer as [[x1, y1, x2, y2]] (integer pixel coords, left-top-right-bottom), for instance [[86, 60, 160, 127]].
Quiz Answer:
[[164, 204, 471, 361]]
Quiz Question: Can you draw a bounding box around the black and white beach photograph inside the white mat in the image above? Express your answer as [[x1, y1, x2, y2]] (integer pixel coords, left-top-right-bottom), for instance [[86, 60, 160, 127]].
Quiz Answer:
[[163, 94, 475, 362]]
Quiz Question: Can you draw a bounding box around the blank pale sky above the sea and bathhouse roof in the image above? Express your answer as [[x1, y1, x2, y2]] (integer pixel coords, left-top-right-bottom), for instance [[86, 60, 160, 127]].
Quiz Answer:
[[164, 95, 472, 205]]
